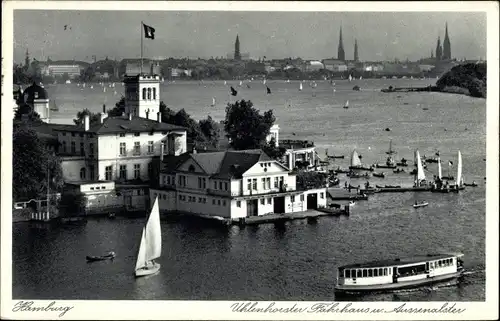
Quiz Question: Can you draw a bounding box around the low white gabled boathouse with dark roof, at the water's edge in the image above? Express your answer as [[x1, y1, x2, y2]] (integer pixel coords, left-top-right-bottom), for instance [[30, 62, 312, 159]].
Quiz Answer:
[[150, 150, 326, 219]]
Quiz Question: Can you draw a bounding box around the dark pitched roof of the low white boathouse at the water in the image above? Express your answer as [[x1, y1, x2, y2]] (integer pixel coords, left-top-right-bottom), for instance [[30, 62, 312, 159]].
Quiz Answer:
[[161, 149, 273, 179]]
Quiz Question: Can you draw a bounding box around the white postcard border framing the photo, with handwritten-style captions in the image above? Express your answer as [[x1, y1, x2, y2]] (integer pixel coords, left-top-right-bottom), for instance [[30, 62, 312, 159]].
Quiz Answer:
[[0, 0, 499, 320]]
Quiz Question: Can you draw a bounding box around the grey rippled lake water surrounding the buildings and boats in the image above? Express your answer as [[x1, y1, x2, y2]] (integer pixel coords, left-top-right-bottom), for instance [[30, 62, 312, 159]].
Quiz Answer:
[[13, 79, 486, 301]]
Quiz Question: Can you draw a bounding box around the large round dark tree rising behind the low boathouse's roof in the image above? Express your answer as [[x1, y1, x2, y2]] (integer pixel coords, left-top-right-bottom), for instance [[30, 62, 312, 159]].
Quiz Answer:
[[224, 100, 276, 150]]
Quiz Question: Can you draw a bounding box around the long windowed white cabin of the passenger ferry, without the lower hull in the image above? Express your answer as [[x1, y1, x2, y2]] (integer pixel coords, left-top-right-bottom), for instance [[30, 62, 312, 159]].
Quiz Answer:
[[337, 254, 462, 285]]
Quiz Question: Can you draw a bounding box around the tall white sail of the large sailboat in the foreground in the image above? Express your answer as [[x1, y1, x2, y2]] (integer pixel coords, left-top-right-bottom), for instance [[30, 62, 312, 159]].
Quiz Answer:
[[135, 198, 161, 270]]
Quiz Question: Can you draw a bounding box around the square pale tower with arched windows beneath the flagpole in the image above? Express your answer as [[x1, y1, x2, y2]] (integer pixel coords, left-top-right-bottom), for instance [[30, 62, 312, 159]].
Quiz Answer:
[[124, 74, 160, 120]]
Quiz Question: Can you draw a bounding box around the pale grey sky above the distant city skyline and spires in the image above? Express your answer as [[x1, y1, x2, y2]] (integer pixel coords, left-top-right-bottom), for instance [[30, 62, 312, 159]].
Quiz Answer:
[[14, 10, 486, 63]]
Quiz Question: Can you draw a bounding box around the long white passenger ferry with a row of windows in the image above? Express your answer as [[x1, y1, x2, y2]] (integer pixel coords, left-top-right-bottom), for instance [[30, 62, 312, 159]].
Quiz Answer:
[[335, 253, 464, 294]]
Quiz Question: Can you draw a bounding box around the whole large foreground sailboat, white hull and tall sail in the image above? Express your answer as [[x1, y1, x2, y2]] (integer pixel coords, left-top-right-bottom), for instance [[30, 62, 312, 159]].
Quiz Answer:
[[135, 197, 161, 277]]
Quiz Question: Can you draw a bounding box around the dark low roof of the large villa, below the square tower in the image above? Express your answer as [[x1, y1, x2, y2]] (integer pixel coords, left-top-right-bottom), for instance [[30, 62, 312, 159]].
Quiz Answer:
[[51, 116, 186, 135]]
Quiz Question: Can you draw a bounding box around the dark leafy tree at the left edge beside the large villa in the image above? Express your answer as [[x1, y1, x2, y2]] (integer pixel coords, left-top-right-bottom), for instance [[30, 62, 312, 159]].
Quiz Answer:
[[12, 125, 63, 200]]
